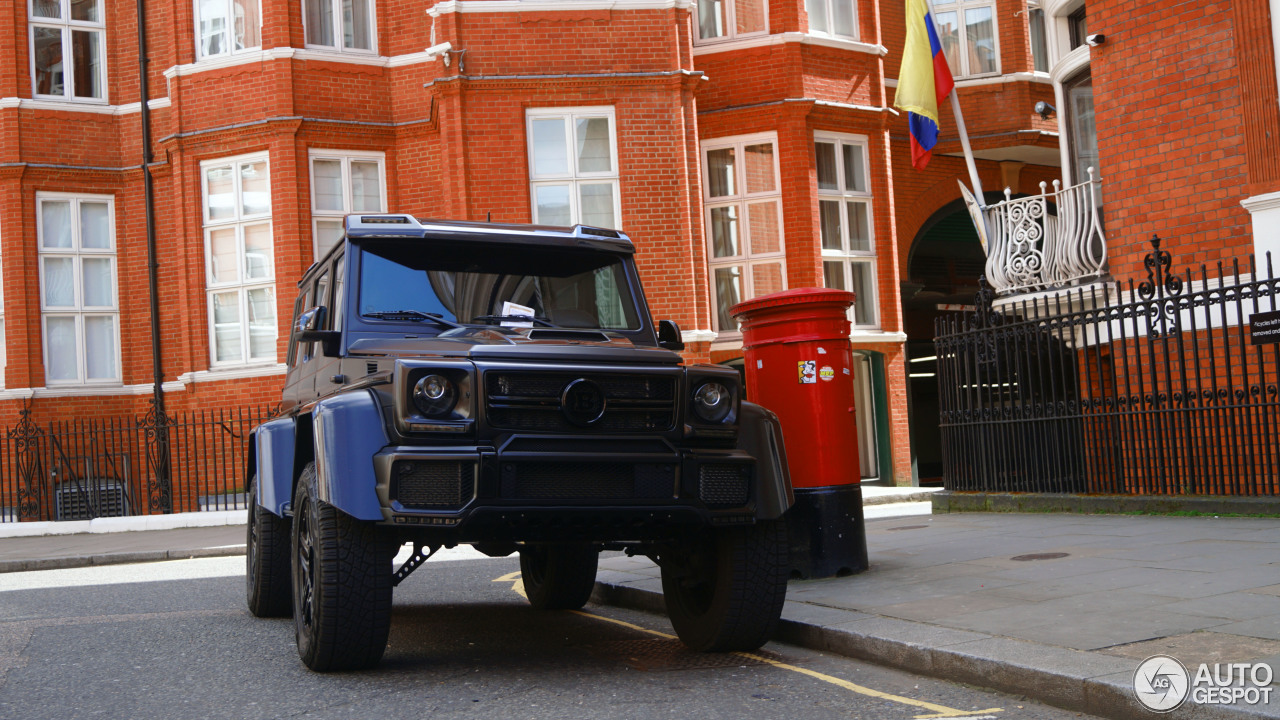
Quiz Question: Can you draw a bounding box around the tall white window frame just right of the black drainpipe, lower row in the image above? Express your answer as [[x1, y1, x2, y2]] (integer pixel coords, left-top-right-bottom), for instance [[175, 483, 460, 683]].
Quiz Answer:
[[200, 152, 280, 369]]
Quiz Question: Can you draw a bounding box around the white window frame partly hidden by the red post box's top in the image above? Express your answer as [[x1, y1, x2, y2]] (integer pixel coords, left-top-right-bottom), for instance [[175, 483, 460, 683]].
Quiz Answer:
[[700, 132, 787, 338]]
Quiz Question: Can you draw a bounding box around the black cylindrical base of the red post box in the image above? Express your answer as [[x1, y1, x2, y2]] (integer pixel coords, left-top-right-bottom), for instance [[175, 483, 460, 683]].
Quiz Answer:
[[786, 486, 868, 579]]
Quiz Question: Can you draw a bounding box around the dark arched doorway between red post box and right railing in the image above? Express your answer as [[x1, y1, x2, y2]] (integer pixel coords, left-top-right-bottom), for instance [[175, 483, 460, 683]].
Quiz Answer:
[[902, 193, 988, 484]]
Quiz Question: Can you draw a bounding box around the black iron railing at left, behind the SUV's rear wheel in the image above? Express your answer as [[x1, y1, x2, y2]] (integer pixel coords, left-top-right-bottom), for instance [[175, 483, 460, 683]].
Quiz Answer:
[[0, 397, 278, 523]]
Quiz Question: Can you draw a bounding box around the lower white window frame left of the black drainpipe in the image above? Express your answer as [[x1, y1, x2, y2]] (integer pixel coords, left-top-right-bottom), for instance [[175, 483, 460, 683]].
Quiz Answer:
[[36, 192, 122, 387]]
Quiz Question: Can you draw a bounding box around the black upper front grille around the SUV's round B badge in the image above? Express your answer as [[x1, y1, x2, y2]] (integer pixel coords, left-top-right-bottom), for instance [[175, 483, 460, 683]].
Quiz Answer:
[[485, 370, 676, 433]]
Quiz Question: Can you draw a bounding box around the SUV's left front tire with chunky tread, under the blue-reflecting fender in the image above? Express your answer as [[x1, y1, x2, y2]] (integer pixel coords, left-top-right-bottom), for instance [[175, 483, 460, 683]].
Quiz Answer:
[[292, 464, 394, 673]]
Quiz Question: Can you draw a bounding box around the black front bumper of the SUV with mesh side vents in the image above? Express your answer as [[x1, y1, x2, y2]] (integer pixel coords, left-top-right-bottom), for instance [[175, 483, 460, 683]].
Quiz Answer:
[[374, 437, 756, 542]]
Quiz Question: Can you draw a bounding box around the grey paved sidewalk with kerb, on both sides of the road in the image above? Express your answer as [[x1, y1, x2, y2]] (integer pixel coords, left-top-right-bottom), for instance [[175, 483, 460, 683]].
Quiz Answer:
[[0, 487, 1280, 720]]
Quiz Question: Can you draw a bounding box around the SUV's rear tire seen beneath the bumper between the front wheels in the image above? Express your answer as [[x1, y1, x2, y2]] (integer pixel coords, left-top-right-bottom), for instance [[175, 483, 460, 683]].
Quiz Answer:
[[520, 543, 600, 610]]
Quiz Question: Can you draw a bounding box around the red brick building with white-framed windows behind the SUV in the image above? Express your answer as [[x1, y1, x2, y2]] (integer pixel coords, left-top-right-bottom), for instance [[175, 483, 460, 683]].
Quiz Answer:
[[0, 0, 1280, 483]]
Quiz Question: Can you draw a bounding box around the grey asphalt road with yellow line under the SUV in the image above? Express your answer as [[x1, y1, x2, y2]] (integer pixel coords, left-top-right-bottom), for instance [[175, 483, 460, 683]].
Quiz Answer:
[[0, 557, 1100, 720]]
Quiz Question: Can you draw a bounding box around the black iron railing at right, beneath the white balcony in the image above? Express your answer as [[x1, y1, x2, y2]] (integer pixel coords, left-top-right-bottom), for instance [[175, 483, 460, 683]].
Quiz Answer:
[[934, 237, 1280, 496]]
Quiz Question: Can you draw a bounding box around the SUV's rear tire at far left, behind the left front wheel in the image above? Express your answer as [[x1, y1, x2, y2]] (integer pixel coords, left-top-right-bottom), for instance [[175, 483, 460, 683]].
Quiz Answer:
[[244, 475, 293, 618]]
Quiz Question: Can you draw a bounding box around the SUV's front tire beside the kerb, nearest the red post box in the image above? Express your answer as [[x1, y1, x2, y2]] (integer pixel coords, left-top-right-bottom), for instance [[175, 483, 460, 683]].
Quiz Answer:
[[662, 520, 790, 651]]
